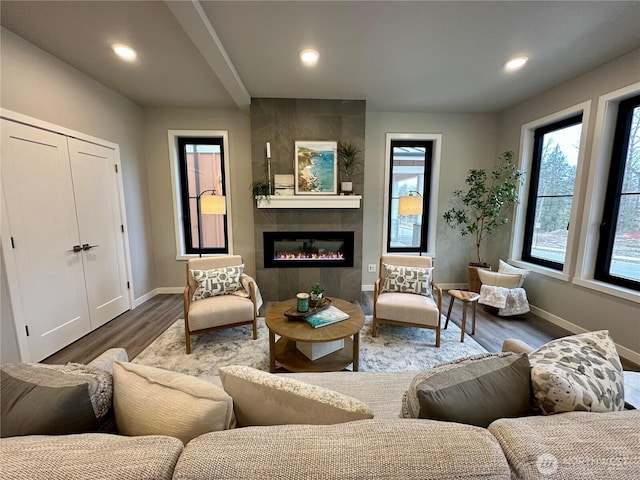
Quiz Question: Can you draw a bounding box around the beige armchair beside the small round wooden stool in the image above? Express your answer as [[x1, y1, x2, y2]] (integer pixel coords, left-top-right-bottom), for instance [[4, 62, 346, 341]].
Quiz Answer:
[[372, 255, 442, 347]]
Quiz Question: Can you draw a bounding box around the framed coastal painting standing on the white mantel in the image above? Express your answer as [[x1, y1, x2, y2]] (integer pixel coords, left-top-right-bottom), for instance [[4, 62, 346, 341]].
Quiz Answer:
[[295, 141, 338, 195]]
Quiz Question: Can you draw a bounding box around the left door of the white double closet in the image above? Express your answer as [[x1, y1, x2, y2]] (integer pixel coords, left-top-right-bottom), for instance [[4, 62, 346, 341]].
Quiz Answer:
[[1, 120, 90, 361]]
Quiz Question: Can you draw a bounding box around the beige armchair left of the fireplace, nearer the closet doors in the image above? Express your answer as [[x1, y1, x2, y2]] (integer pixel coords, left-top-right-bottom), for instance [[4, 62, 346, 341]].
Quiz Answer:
[[184, 255, 262, 353]]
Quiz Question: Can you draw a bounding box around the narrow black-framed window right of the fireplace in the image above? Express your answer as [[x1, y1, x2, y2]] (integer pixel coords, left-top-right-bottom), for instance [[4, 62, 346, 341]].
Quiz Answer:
[[387, 140, 433, 253]]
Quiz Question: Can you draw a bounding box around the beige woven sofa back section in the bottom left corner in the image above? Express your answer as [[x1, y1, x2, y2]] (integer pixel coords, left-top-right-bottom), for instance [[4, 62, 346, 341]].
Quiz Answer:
[[0, 433, 183, 480]]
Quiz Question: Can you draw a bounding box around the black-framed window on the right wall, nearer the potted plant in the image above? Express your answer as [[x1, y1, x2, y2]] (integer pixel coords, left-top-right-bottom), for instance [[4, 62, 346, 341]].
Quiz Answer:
[[522, 114, 582, 270]]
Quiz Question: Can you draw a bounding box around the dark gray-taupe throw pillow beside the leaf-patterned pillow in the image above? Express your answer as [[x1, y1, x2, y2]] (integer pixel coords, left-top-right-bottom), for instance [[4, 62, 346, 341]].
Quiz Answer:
[[402, 353, 531, 427]]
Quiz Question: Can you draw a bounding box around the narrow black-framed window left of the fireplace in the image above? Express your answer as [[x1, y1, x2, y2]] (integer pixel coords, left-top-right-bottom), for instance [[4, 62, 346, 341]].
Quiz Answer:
[[177, 137, 229, 254]]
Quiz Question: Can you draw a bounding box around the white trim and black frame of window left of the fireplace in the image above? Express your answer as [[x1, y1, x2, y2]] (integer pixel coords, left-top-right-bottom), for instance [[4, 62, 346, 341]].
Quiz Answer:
[[168, 130, 233, 260]]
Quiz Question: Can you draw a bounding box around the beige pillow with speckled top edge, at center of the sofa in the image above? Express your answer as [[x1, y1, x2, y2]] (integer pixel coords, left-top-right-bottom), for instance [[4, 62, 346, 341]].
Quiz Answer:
[[219, 365, 373, 427]]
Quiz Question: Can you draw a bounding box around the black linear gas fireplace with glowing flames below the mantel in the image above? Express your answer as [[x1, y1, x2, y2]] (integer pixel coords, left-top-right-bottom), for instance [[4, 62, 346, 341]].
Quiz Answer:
[[263, 232, 353, 268]]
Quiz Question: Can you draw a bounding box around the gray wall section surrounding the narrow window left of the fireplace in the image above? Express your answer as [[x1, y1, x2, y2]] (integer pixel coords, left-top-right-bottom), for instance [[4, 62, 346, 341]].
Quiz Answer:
[[144, 108, 255, 289]]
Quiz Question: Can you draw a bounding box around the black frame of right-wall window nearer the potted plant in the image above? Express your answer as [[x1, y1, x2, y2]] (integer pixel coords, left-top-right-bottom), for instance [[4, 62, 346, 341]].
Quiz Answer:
[[520, 112, 585, 271]]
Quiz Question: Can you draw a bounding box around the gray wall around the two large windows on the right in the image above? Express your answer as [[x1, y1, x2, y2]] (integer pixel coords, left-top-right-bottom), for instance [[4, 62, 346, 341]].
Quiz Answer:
[[498, 50, 640, 361]]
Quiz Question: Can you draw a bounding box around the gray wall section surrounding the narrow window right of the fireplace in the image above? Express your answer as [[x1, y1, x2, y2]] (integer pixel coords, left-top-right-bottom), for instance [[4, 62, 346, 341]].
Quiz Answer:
[[362, 112, 498, 289]]
